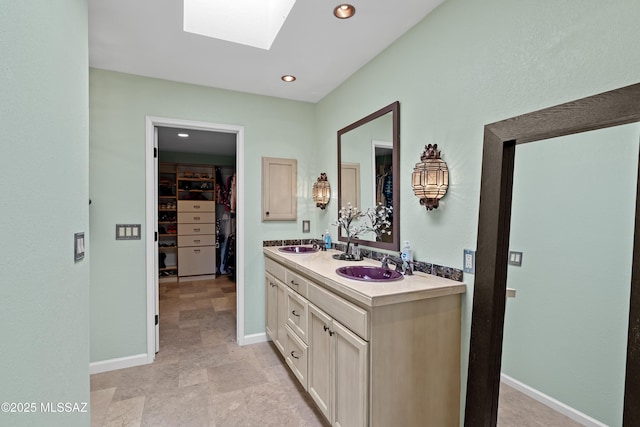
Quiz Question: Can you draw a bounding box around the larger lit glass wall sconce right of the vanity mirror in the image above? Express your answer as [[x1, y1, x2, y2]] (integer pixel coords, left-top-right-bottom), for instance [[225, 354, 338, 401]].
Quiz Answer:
[[411, 144, 449, 211]]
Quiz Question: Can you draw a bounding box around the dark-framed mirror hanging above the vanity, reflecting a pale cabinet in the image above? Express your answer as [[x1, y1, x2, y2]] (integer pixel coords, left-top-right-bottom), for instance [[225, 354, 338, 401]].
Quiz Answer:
[[338, 101, 400, 251]]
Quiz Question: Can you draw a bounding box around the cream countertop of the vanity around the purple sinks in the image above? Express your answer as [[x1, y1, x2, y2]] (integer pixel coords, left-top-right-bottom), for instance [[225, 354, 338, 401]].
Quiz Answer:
[[263, 246, 467, 308]]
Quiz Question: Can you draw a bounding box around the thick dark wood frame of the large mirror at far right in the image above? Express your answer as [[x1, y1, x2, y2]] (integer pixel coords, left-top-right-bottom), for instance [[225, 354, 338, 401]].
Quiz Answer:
[[464, 83, 640, 427]]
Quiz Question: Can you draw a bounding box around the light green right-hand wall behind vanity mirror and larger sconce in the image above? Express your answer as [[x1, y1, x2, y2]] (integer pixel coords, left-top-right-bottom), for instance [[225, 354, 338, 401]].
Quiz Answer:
[[315, 0, 640, 424]]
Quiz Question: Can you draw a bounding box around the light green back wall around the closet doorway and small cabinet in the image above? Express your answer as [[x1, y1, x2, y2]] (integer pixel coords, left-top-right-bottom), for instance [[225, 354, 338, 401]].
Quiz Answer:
[[89, 69, 319, 362]]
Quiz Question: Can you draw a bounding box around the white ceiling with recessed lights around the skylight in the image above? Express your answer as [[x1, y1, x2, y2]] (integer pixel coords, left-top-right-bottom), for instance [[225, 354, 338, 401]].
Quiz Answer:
[[89, 0, 444, 102]]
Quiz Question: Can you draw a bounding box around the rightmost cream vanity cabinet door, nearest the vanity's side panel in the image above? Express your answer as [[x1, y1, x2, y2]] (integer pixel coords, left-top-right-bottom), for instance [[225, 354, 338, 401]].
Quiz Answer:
[[331, 320, 369, 427]]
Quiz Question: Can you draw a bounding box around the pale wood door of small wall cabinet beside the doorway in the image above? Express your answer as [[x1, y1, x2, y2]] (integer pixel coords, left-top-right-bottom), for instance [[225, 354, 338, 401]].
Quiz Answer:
[[262, 157, 298, 221]]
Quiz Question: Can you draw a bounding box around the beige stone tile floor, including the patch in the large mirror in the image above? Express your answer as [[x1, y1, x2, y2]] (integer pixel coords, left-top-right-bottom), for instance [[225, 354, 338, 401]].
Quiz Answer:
[[91, 276, 579, 427]]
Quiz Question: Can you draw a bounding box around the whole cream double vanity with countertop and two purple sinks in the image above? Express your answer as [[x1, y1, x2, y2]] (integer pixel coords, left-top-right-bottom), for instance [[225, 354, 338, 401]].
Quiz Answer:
[[263, 247, 466, 427]]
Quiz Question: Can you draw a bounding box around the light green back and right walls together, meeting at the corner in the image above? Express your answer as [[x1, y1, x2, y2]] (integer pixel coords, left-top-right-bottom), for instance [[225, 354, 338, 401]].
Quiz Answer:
[[90, 0, 640, 422]]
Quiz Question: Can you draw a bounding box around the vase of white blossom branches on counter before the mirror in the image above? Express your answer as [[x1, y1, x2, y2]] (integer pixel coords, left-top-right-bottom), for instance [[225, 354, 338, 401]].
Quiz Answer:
[[332, 203, 392, 260]]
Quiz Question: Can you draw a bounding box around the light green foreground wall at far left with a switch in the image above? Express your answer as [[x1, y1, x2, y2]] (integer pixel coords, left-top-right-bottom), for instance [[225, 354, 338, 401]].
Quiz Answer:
[[0, 0, 90, 426]]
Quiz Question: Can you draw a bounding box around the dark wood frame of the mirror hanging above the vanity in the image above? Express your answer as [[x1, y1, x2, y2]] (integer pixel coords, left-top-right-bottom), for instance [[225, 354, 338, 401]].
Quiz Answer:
[[338, 101, 400, 251]]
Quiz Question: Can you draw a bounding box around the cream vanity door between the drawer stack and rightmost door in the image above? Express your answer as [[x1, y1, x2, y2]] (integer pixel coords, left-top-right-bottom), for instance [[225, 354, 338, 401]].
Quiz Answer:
[[308, 304, 333, 422]]
